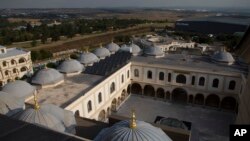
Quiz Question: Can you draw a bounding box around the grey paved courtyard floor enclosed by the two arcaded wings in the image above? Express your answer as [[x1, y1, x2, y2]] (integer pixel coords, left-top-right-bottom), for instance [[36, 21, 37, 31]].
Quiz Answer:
[[117, 95, 235, 141]]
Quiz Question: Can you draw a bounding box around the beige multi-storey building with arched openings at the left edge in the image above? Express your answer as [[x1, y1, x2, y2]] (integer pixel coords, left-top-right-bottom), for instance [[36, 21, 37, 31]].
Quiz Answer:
[[0, 46, 33, 86]]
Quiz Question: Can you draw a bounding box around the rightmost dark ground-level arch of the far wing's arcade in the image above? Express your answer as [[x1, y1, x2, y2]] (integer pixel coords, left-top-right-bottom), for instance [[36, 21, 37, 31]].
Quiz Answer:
[[221, 97, 237, 111]]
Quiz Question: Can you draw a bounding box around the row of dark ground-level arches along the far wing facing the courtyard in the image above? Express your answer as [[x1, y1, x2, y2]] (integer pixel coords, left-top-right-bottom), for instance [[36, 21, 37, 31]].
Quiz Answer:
[[129, 83, 237, 111]]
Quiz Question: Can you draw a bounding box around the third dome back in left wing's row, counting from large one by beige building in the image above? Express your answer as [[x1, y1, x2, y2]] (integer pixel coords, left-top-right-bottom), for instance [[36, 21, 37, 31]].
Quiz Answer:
[[78, 52, 100, 66]]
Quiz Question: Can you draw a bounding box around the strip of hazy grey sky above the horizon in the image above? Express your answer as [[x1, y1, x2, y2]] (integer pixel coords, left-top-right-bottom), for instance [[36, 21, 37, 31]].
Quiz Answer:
[[0, 0, 250, 9]]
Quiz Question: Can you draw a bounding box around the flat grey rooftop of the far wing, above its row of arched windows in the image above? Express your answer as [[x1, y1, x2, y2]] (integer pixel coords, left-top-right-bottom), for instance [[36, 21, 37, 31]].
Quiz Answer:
[[131, 54, 248, 74]]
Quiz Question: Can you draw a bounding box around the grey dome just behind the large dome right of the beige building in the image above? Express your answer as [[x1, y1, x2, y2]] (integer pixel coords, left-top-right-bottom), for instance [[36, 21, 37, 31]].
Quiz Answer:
[[57, 59, 84, 73]]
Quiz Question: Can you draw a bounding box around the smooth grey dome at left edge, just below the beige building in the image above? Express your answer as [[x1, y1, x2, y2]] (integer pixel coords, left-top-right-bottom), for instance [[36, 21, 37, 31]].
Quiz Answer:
[[2, 80, 36, 100]]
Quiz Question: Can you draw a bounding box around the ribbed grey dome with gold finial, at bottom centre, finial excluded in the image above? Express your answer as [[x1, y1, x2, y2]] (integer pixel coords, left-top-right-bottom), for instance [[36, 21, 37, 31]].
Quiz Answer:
[[94, 120, 172, 141]]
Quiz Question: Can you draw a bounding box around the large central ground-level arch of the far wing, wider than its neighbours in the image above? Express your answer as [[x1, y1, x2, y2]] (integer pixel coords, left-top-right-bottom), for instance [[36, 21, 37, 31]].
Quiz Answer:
[[172, 88, 188, 103]]
